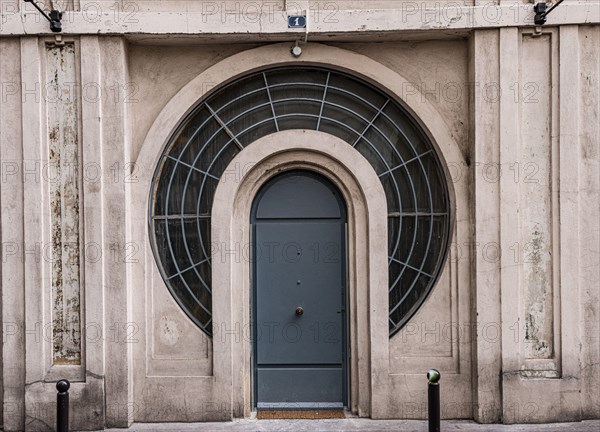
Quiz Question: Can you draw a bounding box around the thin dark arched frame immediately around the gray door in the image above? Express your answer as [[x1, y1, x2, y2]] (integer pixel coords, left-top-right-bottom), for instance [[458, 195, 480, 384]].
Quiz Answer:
[[250, 167, 351, 411]]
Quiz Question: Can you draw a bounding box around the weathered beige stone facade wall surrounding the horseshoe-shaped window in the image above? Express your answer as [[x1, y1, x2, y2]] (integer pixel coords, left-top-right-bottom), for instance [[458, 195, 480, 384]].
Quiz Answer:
[[0, 0, 600, 430]]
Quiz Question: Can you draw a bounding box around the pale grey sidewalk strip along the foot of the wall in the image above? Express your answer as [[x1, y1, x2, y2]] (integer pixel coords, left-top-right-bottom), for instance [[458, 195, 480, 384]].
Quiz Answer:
[[103, 418, 600, 432]]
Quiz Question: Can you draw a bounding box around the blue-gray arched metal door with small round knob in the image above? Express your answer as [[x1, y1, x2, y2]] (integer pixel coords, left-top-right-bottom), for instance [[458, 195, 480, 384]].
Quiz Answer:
[[252, 171, 347, 409]]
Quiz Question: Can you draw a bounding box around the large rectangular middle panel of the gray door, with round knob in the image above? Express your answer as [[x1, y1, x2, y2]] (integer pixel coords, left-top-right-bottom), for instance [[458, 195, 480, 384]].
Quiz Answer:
[[256, 221, 343, 367]]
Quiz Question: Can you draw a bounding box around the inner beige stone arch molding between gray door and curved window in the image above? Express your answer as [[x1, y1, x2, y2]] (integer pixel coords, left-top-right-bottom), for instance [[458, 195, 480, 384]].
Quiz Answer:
[[211, 130, 389, 415]]
